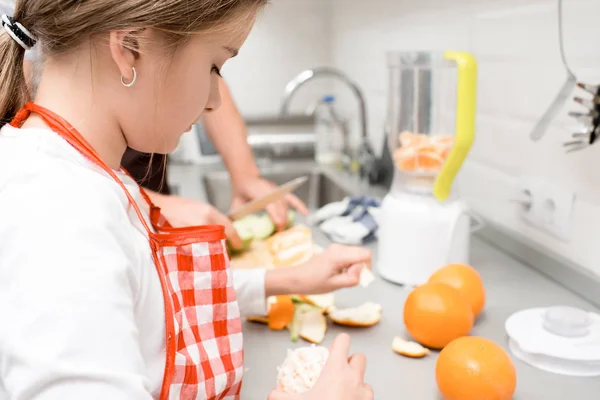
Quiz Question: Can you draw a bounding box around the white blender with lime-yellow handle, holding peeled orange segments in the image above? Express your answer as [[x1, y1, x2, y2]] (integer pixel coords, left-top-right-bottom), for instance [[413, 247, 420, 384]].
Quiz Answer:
[[377, 51, 477, 286]]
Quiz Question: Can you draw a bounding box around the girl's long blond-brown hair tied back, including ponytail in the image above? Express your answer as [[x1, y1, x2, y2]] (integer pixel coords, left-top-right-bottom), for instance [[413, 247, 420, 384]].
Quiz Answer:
[[0, 0, 268, 126]]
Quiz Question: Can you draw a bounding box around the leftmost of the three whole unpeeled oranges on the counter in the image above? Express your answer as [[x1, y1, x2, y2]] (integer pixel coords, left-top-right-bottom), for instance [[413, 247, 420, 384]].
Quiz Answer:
[[404, 283, 473, 349]]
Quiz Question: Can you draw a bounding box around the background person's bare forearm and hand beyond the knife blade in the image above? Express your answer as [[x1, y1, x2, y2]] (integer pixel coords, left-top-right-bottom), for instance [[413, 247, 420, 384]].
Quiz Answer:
[[204, 79, 308, 229]]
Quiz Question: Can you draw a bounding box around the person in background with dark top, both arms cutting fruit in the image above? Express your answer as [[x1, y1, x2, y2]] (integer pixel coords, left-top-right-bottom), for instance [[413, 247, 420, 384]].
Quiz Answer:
[[121, 77, 308, 247]]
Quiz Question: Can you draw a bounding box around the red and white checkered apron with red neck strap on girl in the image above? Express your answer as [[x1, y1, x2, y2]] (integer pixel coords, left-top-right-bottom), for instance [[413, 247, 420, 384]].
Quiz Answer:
[[11, 103, 244, 400]]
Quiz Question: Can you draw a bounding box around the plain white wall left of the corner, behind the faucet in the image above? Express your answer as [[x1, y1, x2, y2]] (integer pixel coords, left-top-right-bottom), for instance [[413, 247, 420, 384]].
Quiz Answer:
[[223, 0, 332, 116]]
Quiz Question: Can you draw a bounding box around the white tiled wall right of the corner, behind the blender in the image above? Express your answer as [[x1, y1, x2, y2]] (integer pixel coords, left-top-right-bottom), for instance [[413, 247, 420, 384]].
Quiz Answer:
[[328, 0, 600, 274]]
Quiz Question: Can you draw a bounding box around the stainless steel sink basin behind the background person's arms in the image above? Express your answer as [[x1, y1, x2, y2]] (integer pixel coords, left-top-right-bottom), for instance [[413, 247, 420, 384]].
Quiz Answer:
[[203, 166, 348, 213]]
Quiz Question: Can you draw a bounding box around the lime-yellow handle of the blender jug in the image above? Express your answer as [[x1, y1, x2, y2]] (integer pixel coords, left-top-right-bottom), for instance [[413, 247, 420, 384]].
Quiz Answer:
[[433, 51, 477, 201]]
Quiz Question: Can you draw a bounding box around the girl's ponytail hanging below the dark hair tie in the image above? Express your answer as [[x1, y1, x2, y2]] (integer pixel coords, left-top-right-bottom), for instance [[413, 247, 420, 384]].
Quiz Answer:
[[0, 20, 30, 127]]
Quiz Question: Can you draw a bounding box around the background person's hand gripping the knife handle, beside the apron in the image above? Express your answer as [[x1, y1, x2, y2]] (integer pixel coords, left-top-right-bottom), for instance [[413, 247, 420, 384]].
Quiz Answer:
[[151, 195, 243, 249]]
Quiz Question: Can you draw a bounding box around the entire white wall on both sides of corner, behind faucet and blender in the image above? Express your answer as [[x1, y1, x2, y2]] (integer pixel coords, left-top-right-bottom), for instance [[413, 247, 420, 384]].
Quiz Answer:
[[220, 0, 600, 274]]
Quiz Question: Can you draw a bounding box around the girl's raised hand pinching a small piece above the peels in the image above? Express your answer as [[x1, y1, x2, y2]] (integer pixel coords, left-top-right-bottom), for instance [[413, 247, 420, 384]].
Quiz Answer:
[[265, 244, 371, 296]]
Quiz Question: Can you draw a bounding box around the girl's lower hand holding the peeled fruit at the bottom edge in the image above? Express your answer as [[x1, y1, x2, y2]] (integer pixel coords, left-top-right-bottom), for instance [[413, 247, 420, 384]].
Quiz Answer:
[[268, 334, 373, 400]]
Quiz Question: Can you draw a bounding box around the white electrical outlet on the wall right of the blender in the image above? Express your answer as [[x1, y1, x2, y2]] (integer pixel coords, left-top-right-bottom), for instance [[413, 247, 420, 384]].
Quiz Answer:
[[519, 177, 575, 241]]
